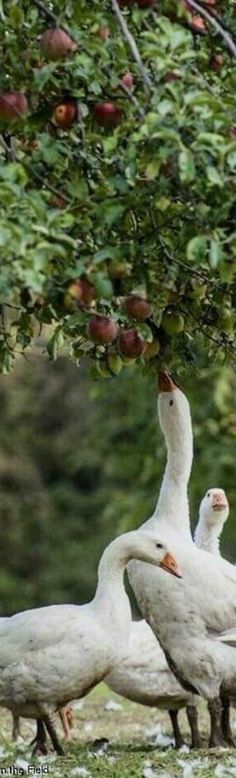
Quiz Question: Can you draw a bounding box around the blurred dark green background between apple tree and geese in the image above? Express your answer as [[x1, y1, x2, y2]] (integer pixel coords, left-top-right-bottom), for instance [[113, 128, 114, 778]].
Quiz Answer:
[[0, 356, 236, 615]]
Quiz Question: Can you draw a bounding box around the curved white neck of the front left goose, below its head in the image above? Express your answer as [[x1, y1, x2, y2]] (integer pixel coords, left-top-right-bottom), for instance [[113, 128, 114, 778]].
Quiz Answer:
[[93, 533, 134, 633]]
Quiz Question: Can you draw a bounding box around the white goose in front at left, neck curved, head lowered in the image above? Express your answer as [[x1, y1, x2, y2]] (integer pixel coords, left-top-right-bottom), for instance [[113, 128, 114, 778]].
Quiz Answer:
[[0, 532, 181, 754]]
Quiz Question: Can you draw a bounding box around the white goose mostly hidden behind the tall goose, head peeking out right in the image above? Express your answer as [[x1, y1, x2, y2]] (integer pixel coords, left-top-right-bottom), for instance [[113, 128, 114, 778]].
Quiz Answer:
[[105, 488, 229, 748]]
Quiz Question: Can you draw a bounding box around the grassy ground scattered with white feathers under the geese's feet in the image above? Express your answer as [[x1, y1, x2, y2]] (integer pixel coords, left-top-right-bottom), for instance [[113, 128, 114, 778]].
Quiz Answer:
[[0, 685, 236, 778]]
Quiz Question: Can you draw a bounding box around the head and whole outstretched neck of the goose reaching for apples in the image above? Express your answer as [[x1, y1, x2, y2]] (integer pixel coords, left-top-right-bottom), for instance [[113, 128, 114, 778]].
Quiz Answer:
[[145, 371, 193, 540]]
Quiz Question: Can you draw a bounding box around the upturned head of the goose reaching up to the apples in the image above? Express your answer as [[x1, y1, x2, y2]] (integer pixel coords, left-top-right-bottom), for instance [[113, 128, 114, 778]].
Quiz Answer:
[[158, 370, 192, 458]]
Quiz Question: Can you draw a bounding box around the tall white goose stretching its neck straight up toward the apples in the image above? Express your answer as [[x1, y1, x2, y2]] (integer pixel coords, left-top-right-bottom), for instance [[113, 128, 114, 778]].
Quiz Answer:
[[129, 372, 236, 746]]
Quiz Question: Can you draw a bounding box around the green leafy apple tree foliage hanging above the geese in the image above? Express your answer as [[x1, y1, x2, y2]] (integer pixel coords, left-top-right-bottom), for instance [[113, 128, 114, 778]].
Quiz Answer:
[[0, 0, 236, 375]]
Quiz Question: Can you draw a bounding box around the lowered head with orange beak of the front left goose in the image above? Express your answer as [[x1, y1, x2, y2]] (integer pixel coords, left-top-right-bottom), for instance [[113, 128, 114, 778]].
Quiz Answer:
[[129, 531, 182, 578]]
